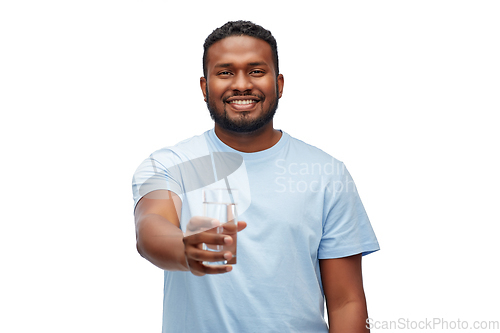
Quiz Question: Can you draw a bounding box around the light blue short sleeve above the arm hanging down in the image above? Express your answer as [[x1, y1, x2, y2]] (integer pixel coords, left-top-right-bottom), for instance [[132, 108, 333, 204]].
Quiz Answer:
[[318, 165, 380, 259]]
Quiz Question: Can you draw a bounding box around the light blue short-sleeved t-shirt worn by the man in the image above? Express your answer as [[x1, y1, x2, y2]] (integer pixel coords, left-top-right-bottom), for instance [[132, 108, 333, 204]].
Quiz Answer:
[[133, 129, 379, 333]]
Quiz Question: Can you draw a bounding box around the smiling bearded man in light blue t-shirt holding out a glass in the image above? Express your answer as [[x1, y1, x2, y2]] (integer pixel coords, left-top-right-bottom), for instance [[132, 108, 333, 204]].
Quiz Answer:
[[133, 21, 379, 333]]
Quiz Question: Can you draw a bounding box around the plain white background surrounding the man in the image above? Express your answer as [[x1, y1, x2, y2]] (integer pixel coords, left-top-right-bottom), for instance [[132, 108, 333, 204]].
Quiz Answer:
[[0, 0, 500, 332]]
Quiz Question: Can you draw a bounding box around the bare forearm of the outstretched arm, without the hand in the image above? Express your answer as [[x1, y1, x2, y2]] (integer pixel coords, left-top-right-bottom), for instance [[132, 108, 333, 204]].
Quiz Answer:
[[137, 214, 188, 271]]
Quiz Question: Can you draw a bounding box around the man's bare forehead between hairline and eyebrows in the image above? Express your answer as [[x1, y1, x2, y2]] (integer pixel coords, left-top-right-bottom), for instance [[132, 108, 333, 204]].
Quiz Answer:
[[207, 36, 274, 70]]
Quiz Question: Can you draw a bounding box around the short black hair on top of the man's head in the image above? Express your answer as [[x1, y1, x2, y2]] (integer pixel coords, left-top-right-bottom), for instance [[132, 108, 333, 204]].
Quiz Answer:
[[203, 20, 280, 78]]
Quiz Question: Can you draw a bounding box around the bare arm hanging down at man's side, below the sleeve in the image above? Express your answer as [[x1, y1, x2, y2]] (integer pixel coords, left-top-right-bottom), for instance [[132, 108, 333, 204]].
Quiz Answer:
[[319, 254, 370, 333]]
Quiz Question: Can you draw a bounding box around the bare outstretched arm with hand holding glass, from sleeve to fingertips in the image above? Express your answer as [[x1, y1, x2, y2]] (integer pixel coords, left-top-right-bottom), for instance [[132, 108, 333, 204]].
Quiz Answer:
[[135, 190, 247, 276]]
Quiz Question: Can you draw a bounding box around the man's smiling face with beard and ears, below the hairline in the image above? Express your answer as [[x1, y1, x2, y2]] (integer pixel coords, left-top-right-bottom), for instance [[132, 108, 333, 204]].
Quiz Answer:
[[200, 36, 283, 133]]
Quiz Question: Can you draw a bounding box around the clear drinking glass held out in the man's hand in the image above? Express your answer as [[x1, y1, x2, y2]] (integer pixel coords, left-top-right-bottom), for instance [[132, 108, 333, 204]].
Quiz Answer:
[[203, 188, 238, 265]]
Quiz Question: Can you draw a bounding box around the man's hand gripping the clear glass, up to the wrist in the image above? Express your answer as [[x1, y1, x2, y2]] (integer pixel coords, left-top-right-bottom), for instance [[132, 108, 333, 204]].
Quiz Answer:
[[183, 216, 247, 276]]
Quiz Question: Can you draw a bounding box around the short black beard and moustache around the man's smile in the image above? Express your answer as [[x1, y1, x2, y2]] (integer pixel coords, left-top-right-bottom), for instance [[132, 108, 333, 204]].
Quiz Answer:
[[206, 84, 279, 133]]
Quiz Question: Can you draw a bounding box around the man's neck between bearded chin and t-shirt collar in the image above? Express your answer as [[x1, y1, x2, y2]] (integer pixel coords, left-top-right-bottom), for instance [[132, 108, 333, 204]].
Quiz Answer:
[[215, 121, 282, 153]]
